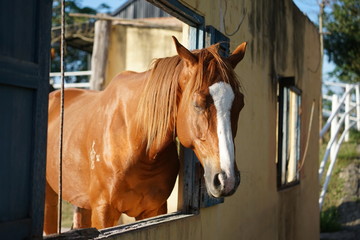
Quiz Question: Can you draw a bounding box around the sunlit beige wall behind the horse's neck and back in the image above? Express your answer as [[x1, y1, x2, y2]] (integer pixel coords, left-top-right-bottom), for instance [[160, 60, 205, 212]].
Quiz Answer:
[[105, 20, 182, 86]]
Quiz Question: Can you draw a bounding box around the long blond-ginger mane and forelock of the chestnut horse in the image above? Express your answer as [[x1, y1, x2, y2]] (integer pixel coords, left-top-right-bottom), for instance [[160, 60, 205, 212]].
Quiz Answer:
[[136, 45, 240, 150]]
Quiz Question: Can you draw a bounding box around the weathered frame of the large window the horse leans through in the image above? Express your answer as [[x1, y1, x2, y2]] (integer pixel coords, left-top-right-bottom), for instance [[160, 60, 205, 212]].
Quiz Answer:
[[45, 0, 205, 239]]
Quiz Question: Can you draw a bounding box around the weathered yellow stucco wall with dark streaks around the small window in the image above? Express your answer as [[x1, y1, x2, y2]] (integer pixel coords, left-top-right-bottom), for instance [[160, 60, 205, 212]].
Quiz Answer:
[[102, 0, 321, 240]]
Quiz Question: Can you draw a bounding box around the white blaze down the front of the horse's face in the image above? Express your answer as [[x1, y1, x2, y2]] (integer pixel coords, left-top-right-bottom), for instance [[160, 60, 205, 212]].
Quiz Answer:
[[209, 82, 235, 181]]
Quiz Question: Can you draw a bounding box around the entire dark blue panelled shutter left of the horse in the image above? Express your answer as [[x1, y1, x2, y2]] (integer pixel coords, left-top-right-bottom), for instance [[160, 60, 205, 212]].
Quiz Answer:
[[0, 0, 52, 239]]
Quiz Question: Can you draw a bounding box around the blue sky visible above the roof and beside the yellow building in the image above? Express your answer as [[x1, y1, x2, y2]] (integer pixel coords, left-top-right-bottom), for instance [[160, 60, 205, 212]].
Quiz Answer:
[[80, 0, 335, 80]]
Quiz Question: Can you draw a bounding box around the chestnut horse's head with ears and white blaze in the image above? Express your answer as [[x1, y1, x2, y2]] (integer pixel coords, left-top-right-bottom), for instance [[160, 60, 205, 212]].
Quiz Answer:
[[174, 38, 246, 198]]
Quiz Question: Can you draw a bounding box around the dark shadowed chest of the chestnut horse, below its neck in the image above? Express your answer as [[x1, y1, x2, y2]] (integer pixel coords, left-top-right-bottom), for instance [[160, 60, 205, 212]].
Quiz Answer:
[[114, 143, 179, 217]]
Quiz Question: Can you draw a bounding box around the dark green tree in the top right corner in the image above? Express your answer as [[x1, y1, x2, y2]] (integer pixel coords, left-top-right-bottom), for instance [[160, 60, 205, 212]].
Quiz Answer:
[[324, 0, 360, 83]]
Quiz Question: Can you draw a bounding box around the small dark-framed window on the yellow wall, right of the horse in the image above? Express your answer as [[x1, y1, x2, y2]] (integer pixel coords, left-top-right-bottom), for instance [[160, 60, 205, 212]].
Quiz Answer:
[[276, 77, 302, 190]]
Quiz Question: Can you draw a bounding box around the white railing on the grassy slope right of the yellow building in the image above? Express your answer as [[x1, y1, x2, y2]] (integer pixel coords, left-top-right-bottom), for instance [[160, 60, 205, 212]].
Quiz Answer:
[[319, 82, 360, 210]]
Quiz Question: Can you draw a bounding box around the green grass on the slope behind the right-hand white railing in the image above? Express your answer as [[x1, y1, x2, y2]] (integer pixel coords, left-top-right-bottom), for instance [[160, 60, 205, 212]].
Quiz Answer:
[[320, 130, 360, 232]]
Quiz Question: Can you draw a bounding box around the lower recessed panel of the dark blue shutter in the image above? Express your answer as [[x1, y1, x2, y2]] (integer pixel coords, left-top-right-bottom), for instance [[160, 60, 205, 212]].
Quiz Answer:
[[0, 85, 34, 222]]
